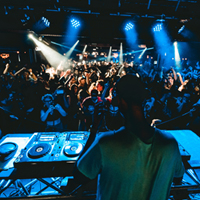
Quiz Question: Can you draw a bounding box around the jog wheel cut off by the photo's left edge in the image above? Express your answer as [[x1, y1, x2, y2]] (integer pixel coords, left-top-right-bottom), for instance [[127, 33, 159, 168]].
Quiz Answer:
[[0, 142, 18, 161]]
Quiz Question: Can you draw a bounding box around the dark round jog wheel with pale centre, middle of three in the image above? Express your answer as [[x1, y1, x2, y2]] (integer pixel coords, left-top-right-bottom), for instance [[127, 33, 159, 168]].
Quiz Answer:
[[28, 143, 51, 159]]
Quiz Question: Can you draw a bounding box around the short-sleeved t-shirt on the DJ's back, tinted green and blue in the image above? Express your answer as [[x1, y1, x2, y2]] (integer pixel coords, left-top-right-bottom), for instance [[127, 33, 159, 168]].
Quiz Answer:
[[78, 128, 184, 200]]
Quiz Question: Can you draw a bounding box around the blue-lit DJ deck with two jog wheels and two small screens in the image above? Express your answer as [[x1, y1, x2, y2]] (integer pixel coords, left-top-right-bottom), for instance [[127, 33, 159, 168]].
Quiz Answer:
[[14, 131, 89, 168]]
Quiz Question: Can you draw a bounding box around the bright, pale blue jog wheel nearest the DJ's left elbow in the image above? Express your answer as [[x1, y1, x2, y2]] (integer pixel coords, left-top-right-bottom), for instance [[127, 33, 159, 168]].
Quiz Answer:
[[64, 142, 83, 157]]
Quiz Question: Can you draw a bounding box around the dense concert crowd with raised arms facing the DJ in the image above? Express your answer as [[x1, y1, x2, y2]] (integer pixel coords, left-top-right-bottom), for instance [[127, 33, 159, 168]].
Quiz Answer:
[[0, 57, 200, 137]]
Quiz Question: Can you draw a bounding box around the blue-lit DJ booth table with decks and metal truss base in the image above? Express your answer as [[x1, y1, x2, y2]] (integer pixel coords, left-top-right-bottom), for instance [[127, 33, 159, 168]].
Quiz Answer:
[[0, 130, 200, 199]]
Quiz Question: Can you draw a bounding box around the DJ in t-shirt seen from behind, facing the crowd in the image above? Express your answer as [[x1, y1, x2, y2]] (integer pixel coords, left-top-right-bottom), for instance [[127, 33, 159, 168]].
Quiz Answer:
[[74, 74, 184, 200]]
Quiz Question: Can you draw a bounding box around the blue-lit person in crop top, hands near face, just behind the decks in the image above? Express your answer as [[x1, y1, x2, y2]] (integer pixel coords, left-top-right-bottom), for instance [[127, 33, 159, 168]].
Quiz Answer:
[[40, 94, 67, 131]]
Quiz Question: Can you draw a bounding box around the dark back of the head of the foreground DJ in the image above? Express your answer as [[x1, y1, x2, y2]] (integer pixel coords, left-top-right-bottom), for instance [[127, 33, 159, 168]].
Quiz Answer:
[[116, 74, 146, 105]]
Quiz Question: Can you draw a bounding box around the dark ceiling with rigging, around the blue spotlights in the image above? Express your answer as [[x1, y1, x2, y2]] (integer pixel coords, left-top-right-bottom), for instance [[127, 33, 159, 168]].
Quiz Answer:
[[0, 0, 200, 46]]
